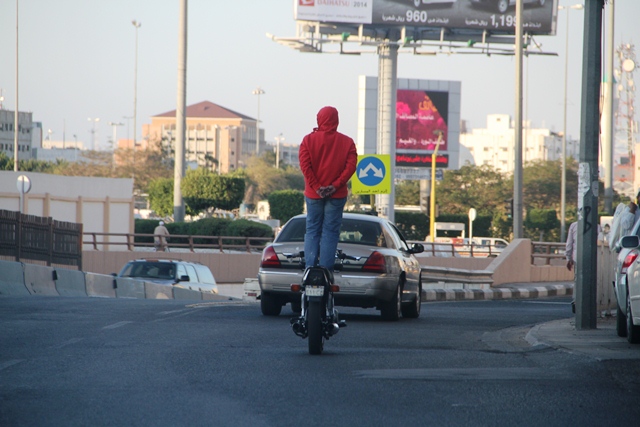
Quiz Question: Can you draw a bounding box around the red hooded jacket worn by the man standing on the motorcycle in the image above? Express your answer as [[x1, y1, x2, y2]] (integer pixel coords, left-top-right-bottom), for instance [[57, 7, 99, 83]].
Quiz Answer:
[[299, 107, 358, 199]]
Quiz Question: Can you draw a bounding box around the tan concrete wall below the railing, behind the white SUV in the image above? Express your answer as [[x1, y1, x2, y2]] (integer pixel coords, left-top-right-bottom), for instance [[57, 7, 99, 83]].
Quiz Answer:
[[82, 251, 262, 283]]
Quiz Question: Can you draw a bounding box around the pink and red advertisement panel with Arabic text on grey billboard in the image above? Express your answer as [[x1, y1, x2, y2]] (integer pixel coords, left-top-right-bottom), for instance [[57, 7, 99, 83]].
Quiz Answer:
[[396, 90, 449, 152]]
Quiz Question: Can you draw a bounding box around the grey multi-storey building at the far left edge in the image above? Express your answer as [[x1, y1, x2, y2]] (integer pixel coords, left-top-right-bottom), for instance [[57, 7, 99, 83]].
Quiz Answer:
[[0, 109, 35, 160]]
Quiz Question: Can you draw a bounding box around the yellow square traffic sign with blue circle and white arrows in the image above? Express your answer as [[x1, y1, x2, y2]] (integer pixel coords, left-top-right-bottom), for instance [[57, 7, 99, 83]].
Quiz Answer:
[[351, 154, 391, 194]]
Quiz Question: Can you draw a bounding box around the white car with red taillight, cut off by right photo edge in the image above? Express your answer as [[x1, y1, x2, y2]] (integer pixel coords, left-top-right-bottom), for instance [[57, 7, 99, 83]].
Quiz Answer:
[[616, 235, 640, 344]]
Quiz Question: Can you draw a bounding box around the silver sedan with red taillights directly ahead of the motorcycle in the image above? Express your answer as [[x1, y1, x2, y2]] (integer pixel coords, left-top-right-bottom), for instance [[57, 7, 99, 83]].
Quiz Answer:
[[258, 213, 424, 320]]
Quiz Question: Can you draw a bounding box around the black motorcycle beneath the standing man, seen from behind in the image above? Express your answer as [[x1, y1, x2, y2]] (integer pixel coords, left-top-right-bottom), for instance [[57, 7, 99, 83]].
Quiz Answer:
[[291, 250, 358, 354]]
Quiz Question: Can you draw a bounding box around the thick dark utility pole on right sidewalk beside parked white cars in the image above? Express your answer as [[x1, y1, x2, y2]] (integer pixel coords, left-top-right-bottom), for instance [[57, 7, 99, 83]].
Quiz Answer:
[[575, 0, 604, 329]]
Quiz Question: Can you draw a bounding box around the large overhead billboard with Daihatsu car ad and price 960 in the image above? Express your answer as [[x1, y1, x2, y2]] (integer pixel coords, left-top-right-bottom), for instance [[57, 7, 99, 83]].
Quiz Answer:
[[293, 0, 558, 35]]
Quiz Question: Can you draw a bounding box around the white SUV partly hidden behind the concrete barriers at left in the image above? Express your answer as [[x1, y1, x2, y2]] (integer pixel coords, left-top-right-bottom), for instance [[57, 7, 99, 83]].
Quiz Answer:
[[116, 259, 218, 294]]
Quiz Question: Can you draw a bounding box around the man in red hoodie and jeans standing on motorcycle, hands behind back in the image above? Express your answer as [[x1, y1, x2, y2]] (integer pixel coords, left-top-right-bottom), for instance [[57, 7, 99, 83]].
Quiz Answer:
[[299, 107, 358, 271]]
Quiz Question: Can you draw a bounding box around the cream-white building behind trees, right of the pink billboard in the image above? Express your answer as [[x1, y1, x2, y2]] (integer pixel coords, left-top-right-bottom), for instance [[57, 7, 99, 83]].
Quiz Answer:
[[460, 114, 580, 173]]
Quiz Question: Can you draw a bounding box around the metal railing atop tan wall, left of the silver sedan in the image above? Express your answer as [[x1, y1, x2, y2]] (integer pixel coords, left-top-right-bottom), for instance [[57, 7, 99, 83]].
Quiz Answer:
[[82, 232, 273, 253]]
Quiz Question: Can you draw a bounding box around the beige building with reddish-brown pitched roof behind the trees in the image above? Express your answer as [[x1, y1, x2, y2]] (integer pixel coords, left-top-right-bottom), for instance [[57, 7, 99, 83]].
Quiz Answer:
[[142, 101, 264, 173]]
